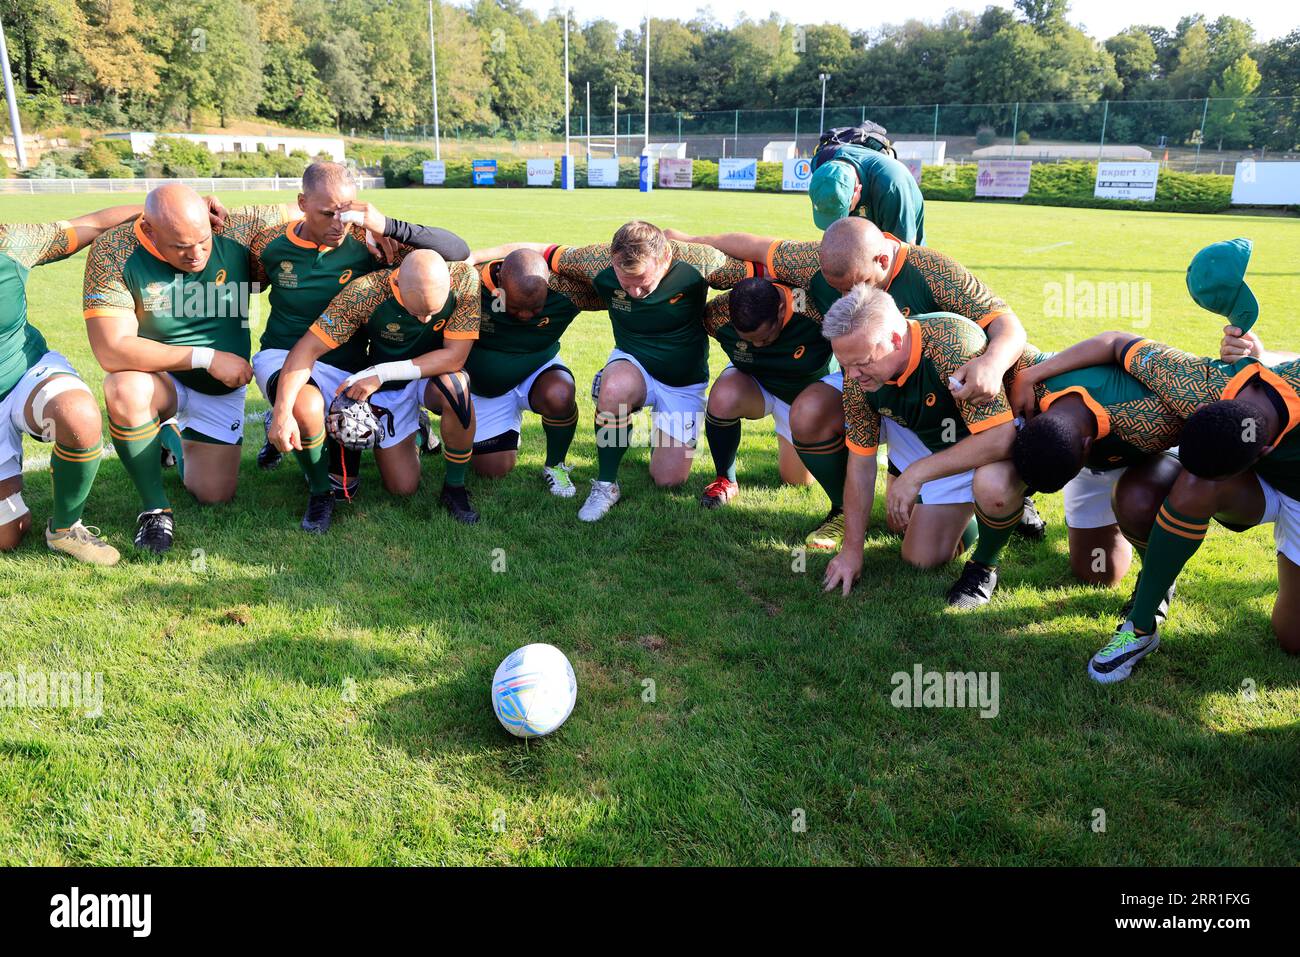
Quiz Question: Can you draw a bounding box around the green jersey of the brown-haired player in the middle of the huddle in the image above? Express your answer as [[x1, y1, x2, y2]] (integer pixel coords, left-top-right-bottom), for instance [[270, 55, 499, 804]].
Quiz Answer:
[[546, 242, 754, 386]]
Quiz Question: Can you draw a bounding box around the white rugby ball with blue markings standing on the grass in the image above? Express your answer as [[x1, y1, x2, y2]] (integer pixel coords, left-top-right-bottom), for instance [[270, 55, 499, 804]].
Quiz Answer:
[[491, 644, 577, 737]]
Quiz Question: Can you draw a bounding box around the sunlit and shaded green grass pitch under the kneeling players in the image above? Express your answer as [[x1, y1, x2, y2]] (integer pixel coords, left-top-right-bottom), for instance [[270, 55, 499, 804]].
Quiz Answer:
[[0, 190, 1300, 865]]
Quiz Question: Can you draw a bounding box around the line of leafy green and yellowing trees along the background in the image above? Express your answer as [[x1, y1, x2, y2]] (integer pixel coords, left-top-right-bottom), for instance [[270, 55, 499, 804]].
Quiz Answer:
[[0, 0, 1300, 150]]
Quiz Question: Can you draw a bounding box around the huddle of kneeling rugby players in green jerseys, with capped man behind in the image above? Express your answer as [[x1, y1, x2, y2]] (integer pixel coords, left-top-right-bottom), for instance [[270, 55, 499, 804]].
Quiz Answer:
[[0, 140, 1300, 683]]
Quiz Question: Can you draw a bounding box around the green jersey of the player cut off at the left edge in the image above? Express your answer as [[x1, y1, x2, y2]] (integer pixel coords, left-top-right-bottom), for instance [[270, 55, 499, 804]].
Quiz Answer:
[[0, 221, 77, 399]]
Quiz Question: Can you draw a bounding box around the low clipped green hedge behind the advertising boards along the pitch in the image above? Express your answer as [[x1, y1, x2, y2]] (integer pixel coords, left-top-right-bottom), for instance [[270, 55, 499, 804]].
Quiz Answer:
[[381, 147, 1232, 213]]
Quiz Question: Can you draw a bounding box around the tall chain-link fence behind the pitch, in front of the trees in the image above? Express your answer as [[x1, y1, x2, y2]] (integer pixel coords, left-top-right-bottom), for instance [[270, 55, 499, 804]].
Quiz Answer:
[[364, 96, 1300, 173]]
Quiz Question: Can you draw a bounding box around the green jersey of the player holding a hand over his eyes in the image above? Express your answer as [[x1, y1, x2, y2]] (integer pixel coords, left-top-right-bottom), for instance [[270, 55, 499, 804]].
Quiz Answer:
[[251, 218, 384, 372]]
